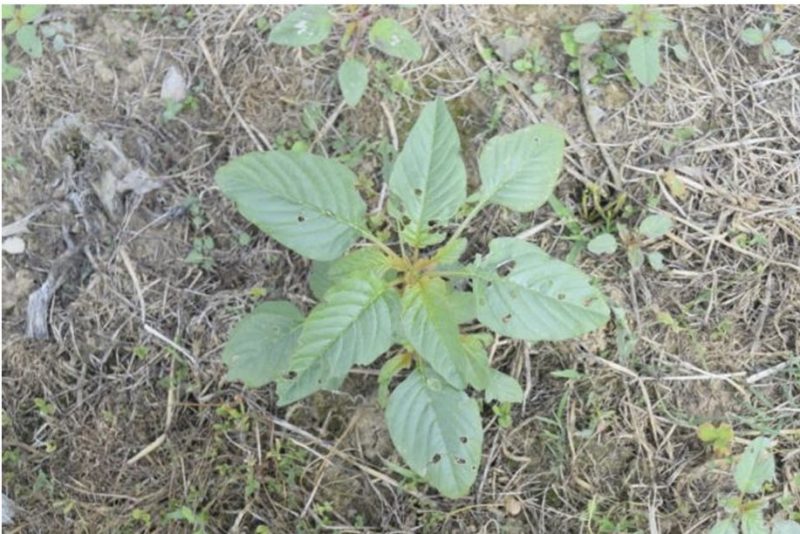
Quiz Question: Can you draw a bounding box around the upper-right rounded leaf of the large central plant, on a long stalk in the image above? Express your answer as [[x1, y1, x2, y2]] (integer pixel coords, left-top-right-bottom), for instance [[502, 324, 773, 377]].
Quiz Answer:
[[478, 124, 564, 212]]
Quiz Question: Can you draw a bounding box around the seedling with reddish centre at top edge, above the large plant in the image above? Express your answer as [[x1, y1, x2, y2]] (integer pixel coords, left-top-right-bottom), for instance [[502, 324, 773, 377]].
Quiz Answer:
[[264, 6, 422, 107]]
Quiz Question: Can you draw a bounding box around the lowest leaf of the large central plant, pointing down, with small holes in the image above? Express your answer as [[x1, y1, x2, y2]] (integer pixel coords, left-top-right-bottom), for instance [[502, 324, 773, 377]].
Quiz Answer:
[[386, 371, 483, 499]]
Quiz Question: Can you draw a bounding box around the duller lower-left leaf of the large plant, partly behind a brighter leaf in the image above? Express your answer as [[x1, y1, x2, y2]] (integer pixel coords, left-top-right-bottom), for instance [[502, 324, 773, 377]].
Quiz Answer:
[[222, 300, 303, 387]]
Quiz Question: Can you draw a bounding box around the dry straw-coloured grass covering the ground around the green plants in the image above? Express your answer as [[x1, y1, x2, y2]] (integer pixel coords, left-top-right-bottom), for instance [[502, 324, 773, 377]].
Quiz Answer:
[[3, 6, 800, 533]]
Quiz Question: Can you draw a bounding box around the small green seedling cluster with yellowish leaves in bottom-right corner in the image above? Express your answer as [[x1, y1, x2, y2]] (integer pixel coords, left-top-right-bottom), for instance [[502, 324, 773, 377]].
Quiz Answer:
[[697, 436, 800, 534]]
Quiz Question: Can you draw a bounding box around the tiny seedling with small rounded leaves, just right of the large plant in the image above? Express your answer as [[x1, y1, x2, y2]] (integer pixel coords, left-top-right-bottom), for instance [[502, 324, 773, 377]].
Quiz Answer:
[[586, 214, 672, 271]]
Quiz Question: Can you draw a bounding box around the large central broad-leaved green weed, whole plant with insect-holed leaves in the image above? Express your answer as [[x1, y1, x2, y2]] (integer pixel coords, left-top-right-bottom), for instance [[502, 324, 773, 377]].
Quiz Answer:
[[216, 100, 609, 498]]
